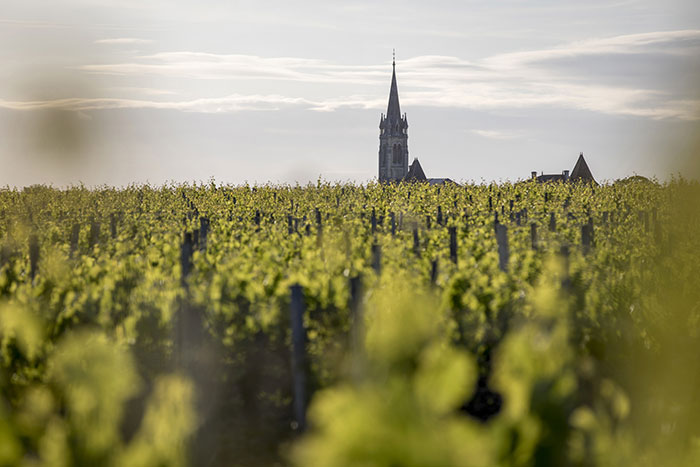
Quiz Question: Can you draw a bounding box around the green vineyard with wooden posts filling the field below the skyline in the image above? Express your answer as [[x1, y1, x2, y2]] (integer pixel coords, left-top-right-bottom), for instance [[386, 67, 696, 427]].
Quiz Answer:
[[0, 179, 700, 467]]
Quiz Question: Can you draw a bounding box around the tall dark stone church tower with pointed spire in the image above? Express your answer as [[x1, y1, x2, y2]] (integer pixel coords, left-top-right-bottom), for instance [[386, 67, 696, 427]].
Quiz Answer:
[[379, 53, 408, 182]]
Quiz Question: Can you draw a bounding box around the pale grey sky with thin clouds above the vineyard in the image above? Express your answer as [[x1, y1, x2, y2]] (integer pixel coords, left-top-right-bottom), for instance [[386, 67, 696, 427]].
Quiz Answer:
[[0, 0, 700, 187]]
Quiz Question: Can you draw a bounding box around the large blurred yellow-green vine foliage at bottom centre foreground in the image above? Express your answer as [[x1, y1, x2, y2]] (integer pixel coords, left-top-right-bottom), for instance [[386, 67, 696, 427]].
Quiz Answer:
[[294, 278, 493, 467]]
